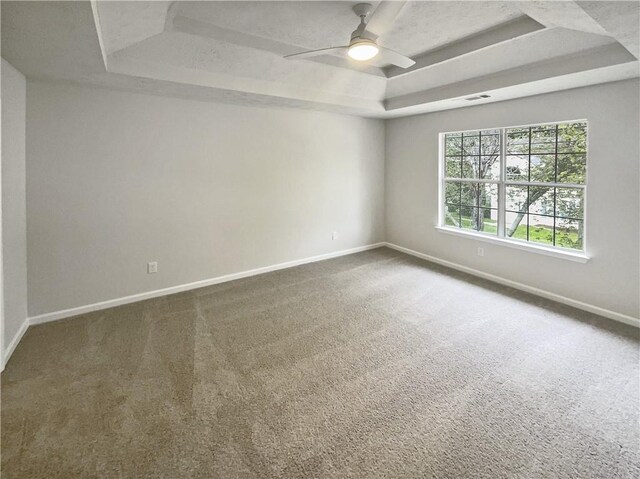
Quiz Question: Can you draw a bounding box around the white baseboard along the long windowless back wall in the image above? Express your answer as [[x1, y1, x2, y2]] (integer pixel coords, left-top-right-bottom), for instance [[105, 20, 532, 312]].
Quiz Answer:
[[29, 243, 385, 324]]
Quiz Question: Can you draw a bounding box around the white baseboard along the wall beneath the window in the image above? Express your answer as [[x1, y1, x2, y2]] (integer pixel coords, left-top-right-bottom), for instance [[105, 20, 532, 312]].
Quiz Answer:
[[386, 243, 640, 328]]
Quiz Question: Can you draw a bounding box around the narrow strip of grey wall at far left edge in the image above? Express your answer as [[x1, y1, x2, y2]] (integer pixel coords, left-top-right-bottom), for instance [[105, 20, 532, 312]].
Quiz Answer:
[[2, 59, 27, 351]]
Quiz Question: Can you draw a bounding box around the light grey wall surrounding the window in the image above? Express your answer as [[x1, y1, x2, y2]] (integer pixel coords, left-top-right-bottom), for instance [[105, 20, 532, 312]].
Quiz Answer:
[[385, 79, 640, 318]]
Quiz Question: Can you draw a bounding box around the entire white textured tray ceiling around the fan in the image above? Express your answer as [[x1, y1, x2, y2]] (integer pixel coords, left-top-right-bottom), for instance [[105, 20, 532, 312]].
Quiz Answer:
[[2, 0, 640, 117]]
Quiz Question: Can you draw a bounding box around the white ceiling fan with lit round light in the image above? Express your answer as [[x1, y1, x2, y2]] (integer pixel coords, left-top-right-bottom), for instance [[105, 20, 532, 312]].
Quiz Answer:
[[284, 1, 416, 68]]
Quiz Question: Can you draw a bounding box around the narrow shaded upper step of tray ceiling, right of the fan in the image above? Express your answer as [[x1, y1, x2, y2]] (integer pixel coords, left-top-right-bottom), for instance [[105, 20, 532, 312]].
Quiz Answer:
[[385, 15, 545, 78]]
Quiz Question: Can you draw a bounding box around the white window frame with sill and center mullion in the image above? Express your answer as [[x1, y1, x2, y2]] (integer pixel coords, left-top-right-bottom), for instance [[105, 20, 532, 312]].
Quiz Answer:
[[436, 119, 590, 263]]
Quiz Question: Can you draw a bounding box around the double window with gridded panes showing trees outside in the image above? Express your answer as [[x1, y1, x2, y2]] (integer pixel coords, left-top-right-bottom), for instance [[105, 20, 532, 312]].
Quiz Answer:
[[440, 121, 587, 252]]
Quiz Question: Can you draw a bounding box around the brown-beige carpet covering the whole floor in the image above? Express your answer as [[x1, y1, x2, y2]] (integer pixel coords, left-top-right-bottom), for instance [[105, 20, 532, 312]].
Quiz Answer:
[[2, 248, 640, 479]]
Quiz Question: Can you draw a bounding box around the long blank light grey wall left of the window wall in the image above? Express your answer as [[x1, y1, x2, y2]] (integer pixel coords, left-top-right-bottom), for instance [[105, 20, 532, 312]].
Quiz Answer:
[[27, 81, 384, 316]]
